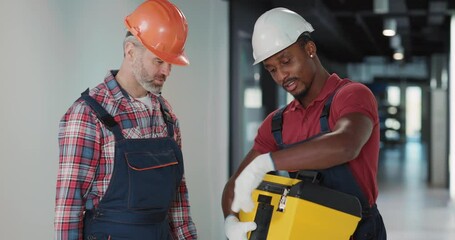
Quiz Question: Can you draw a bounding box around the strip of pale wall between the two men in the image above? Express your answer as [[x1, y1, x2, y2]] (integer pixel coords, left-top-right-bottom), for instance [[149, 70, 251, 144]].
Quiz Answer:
[[163, 0, 229, 240]]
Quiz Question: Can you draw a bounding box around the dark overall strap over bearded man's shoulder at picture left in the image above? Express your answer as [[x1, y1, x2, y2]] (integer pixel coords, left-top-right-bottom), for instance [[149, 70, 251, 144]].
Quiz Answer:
[[81, 88, 124, 141]]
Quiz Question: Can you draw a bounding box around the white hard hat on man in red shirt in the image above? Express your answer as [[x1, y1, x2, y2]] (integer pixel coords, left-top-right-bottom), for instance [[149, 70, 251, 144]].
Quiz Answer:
[[252, 7, 314, 65]]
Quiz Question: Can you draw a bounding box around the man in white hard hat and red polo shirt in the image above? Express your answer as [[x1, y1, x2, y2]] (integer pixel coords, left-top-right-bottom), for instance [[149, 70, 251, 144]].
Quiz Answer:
[[222, 8, 386, 240]]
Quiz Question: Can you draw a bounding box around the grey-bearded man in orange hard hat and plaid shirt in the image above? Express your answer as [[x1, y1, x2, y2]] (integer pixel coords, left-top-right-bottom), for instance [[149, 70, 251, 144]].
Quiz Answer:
[[54, 0, 197, 240]]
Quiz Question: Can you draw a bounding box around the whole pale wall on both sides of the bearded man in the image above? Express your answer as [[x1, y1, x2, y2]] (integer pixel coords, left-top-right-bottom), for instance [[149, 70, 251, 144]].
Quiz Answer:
[[0, 0, 228, 240]]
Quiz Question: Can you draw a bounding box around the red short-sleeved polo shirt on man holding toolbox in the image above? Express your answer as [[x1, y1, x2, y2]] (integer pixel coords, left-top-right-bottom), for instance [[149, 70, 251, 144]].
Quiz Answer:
[[253, 74, 379, 204]]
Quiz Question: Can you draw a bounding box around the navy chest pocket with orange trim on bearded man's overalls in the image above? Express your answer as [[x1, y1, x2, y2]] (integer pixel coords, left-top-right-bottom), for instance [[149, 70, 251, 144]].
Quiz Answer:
[[125, 149, 179, 210]]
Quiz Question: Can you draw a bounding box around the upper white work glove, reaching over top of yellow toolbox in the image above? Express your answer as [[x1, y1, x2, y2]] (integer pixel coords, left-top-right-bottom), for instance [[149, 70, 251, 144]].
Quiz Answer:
[[231, 153, 275, 212]]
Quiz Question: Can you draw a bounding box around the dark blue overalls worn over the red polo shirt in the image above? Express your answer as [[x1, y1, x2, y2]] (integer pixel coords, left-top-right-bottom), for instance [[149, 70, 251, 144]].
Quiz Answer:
[[272, 86, 387, 240]]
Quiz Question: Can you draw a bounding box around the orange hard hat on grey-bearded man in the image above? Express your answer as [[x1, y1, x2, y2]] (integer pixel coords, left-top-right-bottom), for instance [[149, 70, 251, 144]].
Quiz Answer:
[[125, 0, 190, 65]]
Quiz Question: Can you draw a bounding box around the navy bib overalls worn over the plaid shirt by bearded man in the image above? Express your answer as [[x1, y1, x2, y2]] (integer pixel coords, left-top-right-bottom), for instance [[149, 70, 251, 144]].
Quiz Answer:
[[81, 91, 183, 240]]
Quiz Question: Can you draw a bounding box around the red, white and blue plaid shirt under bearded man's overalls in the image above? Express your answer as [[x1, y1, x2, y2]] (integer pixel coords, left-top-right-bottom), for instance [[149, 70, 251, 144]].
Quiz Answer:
[[54, 71, 197, 240]]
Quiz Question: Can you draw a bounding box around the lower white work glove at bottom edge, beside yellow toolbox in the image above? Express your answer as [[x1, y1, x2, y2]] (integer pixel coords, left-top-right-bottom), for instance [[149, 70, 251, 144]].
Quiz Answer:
[[224, 214, 257, 240]]
